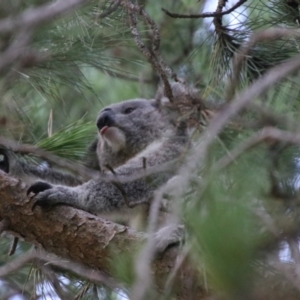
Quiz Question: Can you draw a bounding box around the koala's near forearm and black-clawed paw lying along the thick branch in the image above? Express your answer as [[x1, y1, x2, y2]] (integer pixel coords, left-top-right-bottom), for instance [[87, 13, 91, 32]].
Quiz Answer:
[[28, 175, 155, 214]]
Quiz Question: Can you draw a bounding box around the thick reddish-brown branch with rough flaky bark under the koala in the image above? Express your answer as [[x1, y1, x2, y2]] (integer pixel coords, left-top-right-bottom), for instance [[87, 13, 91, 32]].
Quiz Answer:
[[0, 171, 204, 299]]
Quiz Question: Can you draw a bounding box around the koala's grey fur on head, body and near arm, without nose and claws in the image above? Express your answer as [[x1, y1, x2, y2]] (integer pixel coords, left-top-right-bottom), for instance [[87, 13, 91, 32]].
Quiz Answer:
[[30, 99, 189, 213]]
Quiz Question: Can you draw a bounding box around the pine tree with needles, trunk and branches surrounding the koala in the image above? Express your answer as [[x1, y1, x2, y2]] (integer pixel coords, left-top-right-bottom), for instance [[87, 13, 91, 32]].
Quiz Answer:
[[0, 0, 300, 300]]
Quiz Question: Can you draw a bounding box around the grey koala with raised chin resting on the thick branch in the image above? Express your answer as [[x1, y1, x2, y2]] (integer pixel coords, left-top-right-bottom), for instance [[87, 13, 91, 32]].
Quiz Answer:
[[0, 83, 199, 251]]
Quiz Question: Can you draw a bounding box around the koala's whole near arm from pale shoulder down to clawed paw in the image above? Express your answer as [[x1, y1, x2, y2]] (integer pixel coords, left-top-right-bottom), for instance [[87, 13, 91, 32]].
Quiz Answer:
[[28, 137, 182, 213]]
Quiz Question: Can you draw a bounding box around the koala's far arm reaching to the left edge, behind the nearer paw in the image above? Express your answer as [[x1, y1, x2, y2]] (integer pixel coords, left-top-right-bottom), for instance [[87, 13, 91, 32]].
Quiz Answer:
[[0, 149, 82, 186]]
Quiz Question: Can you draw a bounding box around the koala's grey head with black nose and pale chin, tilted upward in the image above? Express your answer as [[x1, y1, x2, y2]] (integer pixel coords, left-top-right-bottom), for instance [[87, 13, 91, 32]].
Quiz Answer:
[[97, 99, 175, 167]]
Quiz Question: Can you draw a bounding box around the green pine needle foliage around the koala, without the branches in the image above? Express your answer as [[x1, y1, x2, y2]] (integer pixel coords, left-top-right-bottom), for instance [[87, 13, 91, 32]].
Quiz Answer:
[[0, 0, 300, 299]]
